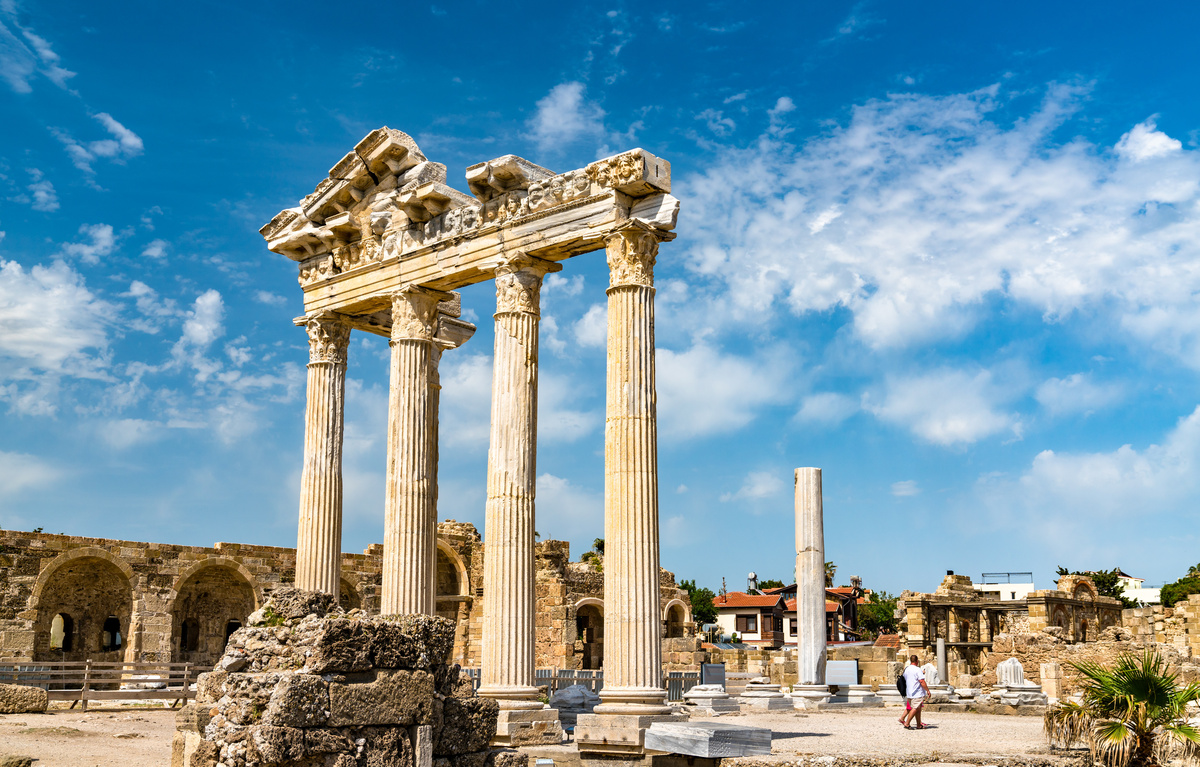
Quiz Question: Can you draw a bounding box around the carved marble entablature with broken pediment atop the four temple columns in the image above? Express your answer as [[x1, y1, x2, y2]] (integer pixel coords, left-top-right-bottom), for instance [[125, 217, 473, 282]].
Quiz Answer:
[[260, 127, 679, 316]]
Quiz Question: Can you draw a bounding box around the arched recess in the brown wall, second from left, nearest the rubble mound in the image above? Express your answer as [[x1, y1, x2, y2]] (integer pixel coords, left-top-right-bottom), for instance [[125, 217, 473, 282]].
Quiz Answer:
[[170, 557, 259, 666]]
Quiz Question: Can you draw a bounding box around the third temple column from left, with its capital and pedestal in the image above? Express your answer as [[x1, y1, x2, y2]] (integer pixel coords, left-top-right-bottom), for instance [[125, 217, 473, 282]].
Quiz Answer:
[[479, 256, 563, 745]]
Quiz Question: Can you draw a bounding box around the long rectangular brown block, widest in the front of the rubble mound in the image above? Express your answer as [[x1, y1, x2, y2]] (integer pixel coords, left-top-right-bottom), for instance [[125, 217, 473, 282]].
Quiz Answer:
[[329, 671, 436, 729]]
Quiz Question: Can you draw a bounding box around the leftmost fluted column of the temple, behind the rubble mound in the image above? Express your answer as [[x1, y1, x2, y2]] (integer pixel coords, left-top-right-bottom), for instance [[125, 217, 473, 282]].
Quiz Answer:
[[295, 316, 350, 597]]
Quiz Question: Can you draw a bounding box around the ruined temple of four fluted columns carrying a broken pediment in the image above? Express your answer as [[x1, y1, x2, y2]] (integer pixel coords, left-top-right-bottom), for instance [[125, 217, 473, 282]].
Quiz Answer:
[[260, 127, 679, 750]]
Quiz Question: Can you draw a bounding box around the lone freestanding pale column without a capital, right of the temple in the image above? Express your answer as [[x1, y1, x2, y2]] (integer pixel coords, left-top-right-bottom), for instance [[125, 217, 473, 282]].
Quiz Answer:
[[796, 468, 827, 685]]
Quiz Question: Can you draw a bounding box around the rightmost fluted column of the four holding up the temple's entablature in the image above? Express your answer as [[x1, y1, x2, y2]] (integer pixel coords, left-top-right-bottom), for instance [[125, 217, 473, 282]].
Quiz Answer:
[[596, 226, 671, 714]]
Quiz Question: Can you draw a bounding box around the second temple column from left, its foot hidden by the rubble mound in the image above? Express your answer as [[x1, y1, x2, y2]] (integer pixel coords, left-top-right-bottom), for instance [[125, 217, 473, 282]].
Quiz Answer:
[[380, 287, 445, 615]]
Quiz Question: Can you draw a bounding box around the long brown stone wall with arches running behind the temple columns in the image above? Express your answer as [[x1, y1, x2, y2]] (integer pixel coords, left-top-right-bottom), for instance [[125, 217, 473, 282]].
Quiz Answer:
[[0, 521, 692, 669]]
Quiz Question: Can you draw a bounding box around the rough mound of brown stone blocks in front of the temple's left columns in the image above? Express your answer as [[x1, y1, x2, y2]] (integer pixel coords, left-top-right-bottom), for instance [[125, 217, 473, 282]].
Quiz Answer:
[[172, 589, 520, 767]]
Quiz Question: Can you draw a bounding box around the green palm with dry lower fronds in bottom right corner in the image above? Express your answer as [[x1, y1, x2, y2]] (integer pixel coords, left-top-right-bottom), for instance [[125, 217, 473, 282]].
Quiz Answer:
[[1044, 649, 1200, 767]]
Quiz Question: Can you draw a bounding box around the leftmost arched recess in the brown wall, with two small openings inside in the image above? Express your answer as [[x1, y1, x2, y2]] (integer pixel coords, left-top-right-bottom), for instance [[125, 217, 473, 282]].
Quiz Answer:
[[30, 547, 136, 661]]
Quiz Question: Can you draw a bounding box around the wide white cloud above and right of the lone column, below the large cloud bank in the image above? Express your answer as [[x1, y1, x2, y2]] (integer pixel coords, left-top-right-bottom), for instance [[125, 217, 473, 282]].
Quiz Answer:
[[864, 370, 1020, 445]]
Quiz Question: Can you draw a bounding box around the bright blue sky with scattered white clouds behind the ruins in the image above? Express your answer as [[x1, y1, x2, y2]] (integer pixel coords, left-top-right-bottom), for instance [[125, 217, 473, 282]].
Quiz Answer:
[[0, 0, 1200, 592]]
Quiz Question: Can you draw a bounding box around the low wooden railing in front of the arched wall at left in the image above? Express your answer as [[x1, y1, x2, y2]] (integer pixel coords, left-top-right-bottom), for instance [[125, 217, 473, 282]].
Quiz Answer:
[[0, 660, 211, 711]]
